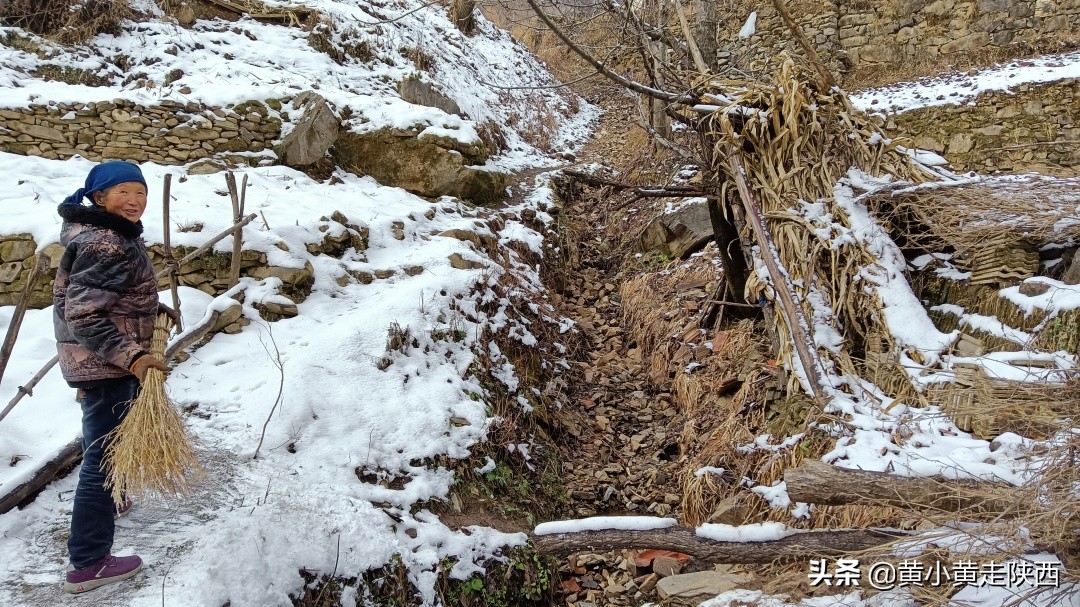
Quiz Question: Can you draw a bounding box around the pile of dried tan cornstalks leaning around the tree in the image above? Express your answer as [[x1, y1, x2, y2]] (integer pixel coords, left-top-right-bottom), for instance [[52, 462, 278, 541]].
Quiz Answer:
[[706, 56, 940, 392]]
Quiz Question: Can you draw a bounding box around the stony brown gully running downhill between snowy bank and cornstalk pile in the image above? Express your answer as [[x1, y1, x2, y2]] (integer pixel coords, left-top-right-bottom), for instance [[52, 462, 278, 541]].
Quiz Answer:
[[535, 93, 704, 606]]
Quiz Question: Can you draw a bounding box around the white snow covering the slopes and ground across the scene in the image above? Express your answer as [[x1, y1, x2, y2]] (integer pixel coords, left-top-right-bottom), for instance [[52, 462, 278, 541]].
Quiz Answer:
[[0, 0, 1080, 607]]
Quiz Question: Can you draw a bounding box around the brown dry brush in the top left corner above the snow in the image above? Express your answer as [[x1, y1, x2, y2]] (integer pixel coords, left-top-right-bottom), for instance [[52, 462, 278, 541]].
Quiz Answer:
[[0, 0, 134, 44]]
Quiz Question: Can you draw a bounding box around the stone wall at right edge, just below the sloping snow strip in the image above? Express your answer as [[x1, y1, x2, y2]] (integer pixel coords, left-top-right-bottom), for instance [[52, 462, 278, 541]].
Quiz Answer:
[[885, 79, 1080, 176]]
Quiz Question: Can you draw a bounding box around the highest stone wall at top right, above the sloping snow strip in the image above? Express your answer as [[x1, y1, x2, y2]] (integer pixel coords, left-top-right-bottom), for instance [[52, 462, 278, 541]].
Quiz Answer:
[[718, 0, 1080, 75]]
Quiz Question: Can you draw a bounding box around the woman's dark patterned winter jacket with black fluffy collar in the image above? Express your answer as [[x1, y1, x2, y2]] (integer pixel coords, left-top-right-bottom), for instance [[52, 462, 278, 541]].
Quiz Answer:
[[53, 204, 158, 388]]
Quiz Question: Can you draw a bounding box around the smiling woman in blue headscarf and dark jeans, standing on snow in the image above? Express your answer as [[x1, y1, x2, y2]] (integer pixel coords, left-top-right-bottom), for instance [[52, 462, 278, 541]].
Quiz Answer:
[[53, 161, 176, 593]]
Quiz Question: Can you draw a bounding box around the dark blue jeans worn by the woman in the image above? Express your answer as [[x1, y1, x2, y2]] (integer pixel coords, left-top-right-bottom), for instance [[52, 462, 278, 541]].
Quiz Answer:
[[68, 376, 139, 569]]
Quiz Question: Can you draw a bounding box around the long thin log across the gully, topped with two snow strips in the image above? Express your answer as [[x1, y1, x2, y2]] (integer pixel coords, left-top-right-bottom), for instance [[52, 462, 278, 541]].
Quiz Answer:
[[532, 527, 912, 564]]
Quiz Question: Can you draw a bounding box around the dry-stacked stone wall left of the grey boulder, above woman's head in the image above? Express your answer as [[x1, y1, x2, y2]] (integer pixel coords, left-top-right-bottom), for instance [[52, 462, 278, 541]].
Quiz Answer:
[[0, 99, 287, 164]]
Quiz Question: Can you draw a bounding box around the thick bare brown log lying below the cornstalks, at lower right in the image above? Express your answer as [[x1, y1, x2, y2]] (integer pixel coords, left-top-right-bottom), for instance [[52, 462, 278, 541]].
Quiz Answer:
[[784, 460, 1031, 515]]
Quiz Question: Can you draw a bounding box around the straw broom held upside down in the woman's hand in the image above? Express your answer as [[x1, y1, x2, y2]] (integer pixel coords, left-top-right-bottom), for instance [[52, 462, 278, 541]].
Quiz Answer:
[[104, 314, 204, 505]]
